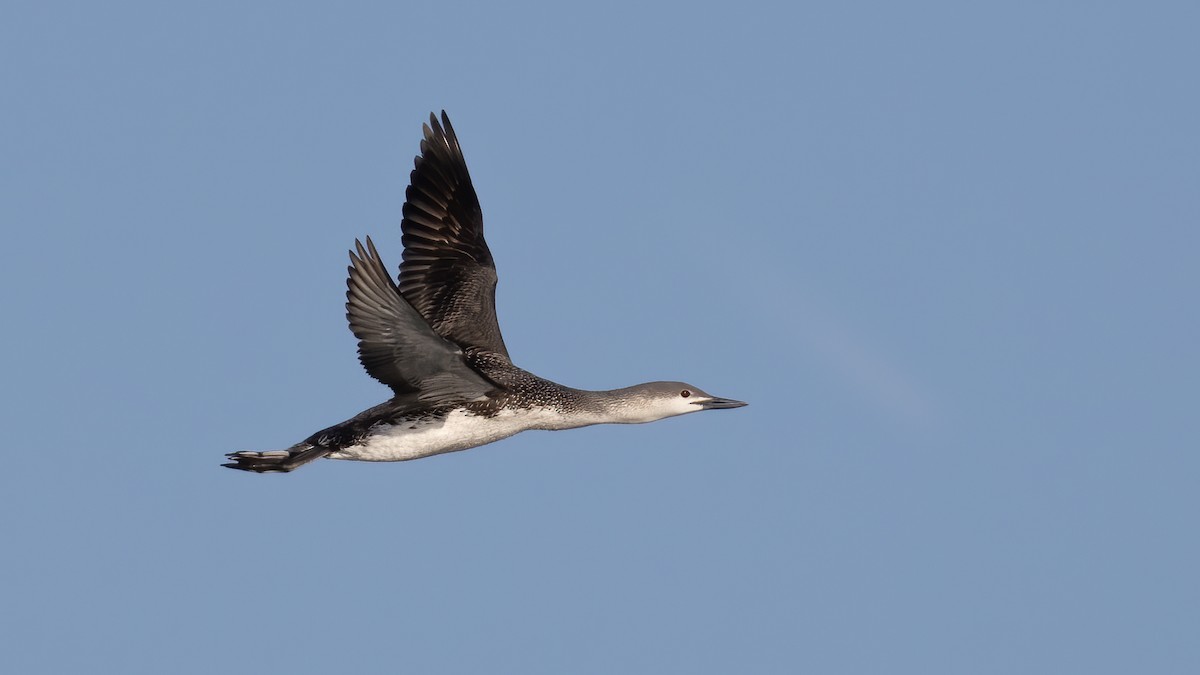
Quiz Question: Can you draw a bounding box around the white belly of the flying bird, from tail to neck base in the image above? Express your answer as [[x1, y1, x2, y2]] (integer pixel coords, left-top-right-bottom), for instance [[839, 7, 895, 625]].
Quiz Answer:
[[329, 408, 562, 461]]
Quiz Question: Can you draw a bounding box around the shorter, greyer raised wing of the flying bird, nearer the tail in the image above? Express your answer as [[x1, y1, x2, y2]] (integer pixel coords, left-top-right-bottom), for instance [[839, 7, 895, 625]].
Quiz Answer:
[[346, 237, 496, 401]]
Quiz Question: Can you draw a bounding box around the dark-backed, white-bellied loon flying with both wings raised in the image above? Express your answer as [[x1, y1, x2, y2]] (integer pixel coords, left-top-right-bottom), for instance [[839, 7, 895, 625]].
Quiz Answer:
[[223, 110, 745, 473]]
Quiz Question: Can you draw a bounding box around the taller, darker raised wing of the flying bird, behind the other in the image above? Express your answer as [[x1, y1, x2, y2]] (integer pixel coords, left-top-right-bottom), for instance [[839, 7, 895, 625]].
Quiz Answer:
[[400, 110, 509, 359]]
